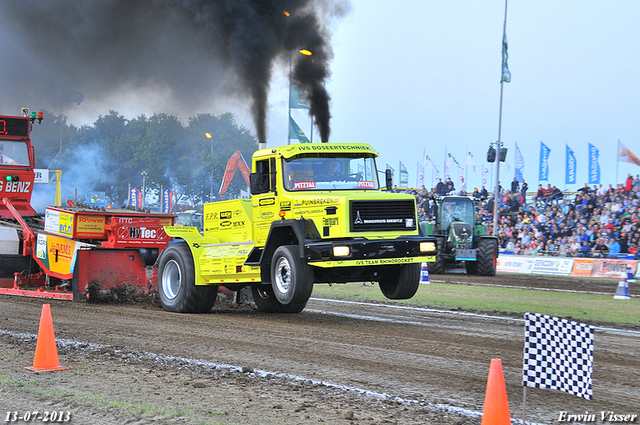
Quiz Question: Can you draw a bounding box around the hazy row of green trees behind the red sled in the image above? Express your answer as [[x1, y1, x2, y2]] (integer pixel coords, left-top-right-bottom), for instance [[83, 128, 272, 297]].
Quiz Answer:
[[26, 111, 257, 207]]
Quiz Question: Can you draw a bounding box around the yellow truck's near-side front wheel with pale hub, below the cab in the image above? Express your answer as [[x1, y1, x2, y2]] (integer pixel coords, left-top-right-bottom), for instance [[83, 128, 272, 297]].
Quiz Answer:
[[271, 245, 313, 305]]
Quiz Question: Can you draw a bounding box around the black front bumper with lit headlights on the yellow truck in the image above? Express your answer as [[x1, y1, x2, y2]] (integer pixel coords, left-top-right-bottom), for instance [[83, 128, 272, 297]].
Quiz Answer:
[[304, 236, 437, 267]]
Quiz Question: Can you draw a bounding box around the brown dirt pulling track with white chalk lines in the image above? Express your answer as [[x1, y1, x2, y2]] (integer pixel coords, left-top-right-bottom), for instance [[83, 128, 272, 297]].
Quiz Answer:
[[0, 275, 640, 424]]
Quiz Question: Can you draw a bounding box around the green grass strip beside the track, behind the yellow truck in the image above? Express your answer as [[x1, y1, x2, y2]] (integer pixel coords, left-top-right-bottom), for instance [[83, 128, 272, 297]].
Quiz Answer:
[[313, 283, 640, 326]]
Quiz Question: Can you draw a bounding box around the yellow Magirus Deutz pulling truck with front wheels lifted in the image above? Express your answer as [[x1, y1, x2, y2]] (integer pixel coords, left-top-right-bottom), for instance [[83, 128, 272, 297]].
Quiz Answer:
[[157, 143, 437, 313]]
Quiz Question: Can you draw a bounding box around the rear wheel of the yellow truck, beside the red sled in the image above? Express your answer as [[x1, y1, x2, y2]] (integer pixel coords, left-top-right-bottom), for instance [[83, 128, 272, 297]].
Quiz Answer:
[[158, 242, 218, 313]]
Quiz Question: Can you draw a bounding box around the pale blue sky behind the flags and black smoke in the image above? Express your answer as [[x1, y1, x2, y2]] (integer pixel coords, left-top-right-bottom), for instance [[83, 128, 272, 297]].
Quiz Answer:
[[3, 0, 640, 190]]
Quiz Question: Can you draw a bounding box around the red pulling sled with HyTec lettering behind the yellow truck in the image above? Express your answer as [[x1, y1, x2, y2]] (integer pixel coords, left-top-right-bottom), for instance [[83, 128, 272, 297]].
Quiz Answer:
[[0, 114, 175, 300]]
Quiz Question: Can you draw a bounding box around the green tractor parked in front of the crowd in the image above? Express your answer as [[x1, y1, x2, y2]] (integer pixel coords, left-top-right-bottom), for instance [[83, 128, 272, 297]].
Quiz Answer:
[[420, 196, 498, 276]]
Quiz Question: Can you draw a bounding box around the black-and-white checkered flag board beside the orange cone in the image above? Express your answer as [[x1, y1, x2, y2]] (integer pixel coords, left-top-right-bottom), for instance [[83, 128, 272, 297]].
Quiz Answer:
[[522, 313, 593, 400]]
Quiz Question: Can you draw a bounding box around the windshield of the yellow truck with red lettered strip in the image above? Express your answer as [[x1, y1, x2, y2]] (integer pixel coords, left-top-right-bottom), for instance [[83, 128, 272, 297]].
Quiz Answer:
[[282, 156, 379, 191]]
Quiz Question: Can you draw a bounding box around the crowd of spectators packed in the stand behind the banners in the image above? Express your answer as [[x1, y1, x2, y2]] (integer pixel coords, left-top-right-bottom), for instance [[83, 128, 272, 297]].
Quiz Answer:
[[413, 174, 640, 258]]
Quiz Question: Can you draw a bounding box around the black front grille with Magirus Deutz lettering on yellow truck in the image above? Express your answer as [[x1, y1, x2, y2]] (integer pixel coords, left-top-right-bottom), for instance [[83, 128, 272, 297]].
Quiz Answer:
[[349, 199, 416, 232]]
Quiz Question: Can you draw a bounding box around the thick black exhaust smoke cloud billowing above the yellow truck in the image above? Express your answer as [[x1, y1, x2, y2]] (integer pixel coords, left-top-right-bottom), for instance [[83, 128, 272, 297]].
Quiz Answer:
[[0, 0, 348, 143]]
